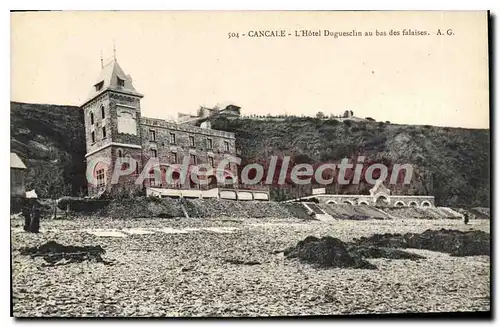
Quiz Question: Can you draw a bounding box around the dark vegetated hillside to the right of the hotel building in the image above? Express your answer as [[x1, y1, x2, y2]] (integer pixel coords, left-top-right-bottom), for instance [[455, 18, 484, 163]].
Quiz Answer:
[[212, 117, 490, 206]]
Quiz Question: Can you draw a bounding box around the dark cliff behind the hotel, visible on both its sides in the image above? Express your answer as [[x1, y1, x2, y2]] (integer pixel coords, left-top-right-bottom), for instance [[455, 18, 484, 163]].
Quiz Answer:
[[11, 102, 491, 207]]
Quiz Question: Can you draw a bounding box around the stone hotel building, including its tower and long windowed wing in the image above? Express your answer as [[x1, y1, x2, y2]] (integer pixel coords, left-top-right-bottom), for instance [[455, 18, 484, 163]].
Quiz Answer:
[[82, 60, 237, 196]]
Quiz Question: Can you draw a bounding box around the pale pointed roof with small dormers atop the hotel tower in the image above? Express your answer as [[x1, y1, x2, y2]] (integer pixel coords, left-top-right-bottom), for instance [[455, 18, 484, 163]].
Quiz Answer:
[[85, 59, 142, 102]]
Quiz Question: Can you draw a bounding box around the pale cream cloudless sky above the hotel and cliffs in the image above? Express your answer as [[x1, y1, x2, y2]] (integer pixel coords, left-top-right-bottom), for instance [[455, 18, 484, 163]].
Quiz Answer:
[[11, 11, 489, 128]]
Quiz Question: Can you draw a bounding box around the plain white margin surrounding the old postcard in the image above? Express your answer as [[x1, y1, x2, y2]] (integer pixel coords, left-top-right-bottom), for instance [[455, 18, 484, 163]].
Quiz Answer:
[[0, 0, 500, 326]]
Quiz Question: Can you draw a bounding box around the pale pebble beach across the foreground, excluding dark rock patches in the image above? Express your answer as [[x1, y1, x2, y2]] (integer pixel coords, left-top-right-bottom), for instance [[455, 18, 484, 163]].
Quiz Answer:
[[11, 217, 490, 317]]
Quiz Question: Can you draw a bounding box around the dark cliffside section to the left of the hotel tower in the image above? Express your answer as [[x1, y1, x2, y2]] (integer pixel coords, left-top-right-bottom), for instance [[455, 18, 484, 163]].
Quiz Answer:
[[10, 102, 86, 197]]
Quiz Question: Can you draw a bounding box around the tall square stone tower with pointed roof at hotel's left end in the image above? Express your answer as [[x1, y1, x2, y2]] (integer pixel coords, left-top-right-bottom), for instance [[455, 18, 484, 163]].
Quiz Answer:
[[81, 56, 143, 195]]
